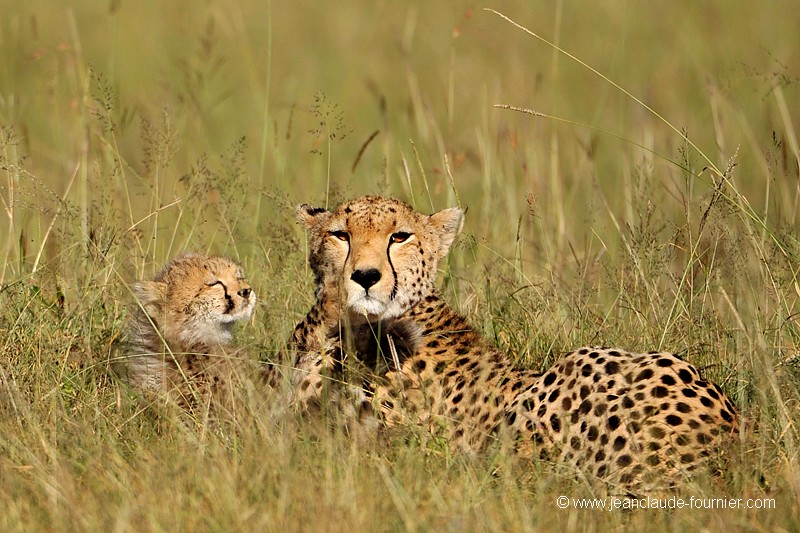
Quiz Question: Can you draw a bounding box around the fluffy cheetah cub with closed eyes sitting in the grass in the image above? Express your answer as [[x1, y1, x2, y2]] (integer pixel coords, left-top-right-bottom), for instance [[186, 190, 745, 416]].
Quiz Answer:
[[114, 254, 256, 411]]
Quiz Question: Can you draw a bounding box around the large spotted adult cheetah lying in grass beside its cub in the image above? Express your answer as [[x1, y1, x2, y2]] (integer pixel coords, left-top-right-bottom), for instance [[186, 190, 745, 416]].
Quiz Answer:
[[291, 196, 738, 484]]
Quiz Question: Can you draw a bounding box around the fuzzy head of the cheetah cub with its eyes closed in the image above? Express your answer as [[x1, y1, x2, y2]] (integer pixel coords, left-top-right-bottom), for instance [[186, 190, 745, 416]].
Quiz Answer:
[[133, 254, 256, 346]]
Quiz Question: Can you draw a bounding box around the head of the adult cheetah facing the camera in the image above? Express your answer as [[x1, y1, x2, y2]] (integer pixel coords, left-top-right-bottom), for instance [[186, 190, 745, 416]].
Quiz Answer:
[[297, 196, 464, 321]]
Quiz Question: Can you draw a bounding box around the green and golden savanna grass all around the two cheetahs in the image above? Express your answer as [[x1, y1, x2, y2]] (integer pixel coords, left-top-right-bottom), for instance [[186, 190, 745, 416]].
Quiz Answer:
[[0, 0, 800, 531]]
